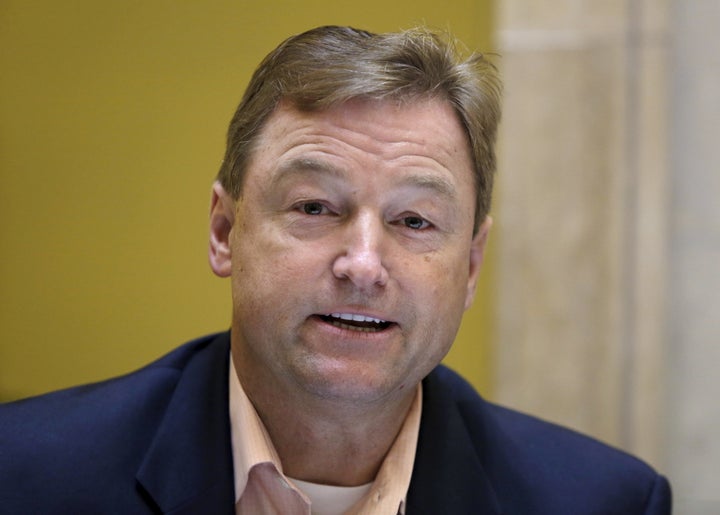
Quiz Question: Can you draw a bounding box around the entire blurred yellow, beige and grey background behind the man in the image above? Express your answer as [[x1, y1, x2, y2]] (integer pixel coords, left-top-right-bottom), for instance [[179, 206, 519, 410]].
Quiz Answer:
[[0, 0, 720, 513]]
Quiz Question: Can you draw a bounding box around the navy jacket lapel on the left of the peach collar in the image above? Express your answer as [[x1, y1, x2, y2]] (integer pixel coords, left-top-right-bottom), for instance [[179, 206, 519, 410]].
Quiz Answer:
[[137, 333, 235, 514]]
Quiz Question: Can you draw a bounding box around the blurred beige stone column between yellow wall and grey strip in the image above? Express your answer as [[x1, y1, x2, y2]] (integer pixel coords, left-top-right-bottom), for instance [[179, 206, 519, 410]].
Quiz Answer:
[[494, 0, 669, 465]]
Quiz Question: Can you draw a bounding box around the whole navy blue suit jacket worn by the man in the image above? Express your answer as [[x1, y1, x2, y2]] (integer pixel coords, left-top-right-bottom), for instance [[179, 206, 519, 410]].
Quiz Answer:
[[0, 333, 670, 515]]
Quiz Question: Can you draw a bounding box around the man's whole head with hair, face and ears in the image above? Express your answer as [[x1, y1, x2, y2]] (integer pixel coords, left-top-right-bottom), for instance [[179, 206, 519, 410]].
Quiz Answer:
[[210, 27, 498, 406]]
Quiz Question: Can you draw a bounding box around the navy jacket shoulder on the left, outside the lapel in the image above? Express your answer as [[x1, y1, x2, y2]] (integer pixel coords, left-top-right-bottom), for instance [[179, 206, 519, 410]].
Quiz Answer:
[[0, 335, 228, 506]]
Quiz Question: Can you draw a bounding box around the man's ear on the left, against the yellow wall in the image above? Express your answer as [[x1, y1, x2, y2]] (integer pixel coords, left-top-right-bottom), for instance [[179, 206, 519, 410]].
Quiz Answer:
[[208, 181, 235, 277]]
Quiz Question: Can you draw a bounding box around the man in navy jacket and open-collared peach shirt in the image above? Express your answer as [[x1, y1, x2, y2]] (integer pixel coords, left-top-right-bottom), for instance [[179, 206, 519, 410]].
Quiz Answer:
[[0, 27, 670, 514]]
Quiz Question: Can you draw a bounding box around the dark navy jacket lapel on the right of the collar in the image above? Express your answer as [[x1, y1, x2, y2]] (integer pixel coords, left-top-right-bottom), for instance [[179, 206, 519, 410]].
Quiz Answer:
[[407, 373, 500, 515]]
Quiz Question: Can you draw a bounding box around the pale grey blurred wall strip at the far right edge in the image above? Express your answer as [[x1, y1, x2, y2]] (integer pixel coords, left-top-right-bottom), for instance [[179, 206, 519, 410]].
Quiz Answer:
[[666, 0, 720, 515]]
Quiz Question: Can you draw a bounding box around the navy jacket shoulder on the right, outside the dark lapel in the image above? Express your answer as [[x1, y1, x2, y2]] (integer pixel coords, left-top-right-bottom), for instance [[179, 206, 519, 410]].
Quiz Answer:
[[423, 367, 670, 513]]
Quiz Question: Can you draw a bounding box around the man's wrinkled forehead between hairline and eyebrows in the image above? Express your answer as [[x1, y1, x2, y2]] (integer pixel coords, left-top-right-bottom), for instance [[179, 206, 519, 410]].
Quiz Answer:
[[248, 98, 472, 182]]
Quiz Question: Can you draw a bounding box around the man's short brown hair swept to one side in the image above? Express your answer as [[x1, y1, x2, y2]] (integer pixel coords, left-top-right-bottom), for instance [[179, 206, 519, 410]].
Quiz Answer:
[[218, 26, 500, 230]]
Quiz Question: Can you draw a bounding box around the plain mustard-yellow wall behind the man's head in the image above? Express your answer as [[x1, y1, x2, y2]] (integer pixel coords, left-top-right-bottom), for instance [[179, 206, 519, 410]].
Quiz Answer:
[[0, 0, 492, 400]]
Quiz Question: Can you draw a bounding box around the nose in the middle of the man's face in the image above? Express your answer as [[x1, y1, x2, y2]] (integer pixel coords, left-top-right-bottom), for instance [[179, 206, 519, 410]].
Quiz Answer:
[[332, 213, 389, 291]]
